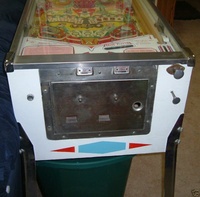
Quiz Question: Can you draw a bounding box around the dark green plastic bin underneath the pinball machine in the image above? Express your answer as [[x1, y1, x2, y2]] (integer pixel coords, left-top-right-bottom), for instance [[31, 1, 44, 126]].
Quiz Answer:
[[37, 156, 133, 197]]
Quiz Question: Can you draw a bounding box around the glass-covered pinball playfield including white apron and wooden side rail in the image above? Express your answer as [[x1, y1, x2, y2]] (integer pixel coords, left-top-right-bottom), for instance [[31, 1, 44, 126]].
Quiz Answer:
[[19, 0, 180, 56]]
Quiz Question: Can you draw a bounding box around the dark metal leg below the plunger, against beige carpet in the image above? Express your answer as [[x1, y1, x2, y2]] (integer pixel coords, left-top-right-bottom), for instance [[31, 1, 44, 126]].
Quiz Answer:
[[164, 114, 184, 197]]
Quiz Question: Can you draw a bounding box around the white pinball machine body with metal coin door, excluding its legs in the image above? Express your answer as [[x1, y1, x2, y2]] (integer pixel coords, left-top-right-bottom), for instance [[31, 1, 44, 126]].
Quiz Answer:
[[5, 0, 194, 160]]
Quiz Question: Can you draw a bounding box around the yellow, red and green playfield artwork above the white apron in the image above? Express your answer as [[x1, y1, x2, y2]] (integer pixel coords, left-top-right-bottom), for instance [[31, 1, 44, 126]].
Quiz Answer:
[[29, 0, 143, 46]]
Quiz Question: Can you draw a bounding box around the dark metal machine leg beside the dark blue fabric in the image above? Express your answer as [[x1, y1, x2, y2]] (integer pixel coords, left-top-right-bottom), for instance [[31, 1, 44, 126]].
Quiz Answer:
[[18, 124, 42, 197]]
